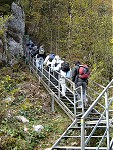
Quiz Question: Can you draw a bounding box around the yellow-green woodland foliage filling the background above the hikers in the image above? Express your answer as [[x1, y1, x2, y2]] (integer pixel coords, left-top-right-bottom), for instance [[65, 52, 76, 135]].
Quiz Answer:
[[21, 0, 113, 80]]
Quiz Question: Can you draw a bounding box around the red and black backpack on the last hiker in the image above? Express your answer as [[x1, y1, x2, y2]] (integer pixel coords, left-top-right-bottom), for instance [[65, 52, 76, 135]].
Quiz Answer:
[[79, 65, 90, 79]]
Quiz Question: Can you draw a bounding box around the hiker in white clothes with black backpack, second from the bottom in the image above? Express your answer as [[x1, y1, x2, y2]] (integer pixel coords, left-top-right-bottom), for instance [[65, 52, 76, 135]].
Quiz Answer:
[[59, 59, 70, 97]]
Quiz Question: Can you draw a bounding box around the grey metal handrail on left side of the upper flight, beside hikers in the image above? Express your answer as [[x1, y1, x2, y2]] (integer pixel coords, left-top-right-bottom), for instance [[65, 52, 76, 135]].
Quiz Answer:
[[27, 53, 84, 120]]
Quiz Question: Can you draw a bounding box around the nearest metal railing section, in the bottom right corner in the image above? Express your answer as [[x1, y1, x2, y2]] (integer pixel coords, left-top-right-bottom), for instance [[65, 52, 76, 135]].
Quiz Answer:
[[81, 80, 113, 150]]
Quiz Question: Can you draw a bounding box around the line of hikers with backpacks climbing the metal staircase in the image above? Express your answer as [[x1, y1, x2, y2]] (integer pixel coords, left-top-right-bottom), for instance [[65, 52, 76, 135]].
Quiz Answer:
[[27, 41, 90, 107]]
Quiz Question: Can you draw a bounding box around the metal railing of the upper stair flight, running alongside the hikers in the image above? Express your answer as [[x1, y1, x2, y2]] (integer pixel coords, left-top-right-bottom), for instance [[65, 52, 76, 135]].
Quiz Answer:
[[25, 49, 84, 120]]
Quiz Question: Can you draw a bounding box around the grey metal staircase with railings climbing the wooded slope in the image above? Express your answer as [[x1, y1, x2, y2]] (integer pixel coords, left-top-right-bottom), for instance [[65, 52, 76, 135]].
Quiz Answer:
[[25, 47, 113, 150]]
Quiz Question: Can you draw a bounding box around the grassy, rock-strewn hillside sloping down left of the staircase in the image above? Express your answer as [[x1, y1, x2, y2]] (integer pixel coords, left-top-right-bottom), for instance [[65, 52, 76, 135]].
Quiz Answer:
[[0, 61, 71, 150]]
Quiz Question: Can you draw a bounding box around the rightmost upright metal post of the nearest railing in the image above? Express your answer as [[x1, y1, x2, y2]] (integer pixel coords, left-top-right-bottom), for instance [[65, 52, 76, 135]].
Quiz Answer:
[[105, 92, 110, 150]]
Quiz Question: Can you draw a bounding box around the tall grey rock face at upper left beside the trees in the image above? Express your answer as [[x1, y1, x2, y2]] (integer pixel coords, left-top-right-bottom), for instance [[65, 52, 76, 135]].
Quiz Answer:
[[6, 2, 25, 57]]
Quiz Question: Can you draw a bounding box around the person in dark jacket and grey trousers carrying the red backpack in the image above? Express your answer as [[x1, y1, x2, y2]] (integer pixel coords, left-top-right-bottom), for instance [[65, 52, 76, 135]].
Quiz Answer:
[[72, 61, 87, 107]]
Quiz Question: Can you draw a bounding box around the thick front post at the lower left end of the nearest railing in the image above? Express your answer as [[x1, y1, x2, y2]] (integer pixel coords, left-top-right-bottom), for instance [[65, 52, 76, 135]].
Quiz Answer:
[[81, 118, 85, 150]]
